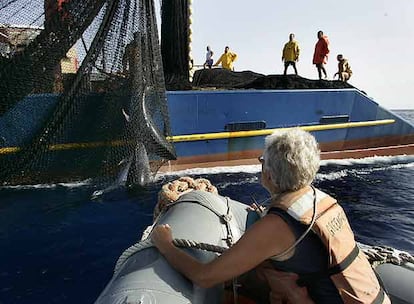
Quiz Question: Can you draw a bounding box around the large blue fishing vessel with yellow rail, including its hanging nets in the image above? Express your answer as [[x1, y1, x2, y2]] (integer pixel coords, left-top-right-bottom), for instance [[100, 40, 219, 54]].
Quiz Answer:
[[0, 0, 414, 184]]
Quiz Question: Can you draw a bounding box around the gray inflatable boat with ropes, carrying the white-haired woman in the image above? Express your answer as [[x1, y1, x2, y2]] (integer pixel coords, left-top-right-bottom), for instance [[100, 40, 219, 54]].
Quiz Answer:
[[95, 191, 414, 304]]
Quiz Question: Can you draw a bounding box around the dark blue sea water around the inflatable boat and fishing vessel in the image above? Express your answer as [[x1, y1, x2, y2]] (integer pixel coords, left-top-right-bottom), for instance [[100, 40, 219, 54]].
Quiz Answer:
[[0, 110, 414, 304]]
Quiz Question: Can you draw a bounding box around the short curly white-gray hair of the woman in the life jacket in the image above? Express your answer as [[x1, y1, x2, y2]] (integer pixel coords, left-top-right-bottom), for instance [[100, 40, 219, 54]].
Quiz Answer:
[[263, 128, 320, 192]]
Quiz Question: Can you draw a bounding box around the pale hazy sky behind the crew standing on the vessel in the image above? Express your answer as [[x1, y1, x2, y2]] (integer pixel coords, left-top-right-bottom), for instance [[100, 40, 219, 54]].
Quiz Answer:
[[191, 0, 414, 109]]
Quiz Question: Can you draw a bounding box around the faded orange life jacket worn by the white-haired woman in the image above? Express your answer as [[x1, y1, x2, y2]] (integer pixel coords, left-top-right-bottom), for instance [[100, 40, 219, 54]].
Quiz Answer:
[[268, 189, 391, 304]]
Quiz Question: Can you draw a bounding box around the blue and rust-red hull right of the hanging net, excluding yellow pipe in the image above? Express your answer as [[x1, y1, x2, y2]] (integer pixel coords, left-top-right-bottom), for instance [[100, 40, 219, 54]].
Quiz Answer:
[[168, 89, 414, 169]]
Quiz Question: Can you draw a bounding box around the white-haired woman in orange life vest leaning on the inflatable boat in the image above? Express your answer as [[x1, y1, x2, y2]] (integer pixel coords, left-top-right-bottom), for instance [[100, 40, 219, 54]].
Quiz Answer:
[[152, 128, 389, 303]]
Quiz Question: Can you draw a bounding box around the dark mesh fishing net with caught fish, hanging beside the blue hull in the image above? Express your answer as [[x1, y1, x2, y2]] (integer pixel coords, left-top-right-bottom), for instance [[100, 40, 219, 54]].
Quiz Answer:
[[0, 0, 175, 185]]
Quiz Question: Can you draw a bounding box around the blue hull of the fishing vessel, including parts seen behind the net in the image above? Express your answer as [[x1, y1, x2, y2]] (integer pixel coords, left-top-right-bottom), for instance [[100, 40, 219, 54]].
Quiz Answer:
[[0, 89, 414, 178]]
